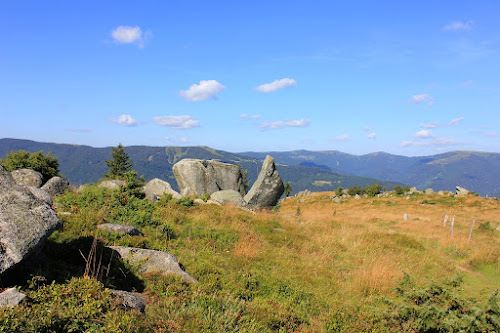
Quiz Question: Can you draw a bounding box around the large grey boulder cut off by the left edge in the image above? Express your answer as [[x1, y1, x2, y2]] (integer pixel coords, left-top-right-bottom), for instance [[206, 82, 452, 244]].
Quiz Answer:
[[0, 166, 60, 277]]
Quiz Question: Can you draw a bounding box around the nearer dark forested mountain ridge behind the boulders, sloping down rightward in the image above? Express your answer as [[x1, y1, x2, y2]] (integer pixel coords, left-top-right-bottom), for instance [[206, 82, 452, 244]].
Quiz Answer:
[[0, 139, 402, 193]]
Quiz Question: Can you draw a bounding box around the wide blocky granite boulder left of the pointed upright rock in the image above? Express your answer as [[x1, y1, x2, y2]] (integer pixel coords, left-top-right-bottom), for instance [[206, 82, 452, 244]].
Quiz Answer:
[[172, 158, 245, 197]]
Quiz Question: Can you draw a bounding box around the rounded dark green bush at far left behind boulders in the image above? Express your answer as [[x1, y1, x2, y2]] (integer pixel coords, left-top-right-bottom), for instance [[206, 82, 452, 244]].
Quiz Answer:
[[0, 150, 59, 182]]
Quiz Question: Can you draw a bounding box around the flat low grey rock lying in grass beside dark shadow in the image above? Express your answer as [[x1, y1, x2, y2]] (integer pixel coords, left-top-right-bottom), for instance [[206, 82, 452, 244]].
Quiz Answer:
[[109, 246, 198, 283]]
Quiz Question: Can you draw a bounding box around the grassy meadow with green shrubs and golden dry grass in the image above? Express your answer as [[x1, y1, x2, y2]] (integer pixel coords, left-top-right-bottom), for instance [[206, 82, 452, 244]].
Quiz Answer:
[[0, 186, 500, 332]]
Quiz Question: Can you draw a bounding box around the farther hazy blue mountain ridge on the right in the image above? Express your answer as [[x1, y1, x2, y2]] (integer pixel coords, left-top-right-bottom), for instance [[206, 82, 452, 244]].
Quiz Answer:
[[240, 150, 500, 197]]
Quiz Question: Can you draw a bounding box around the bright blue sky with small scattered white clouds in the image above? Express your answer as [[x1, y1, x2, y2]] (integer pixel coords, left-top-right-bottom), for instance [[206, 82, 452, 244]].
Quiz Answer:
[[0, 0, 500, 156]]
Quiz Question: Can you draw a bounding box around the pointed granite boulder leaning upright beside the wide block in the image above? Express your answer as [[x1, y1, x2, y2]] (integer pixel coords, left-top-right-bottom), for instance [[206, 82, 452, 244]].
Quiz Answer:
[[244, 155, 285, 207]]
